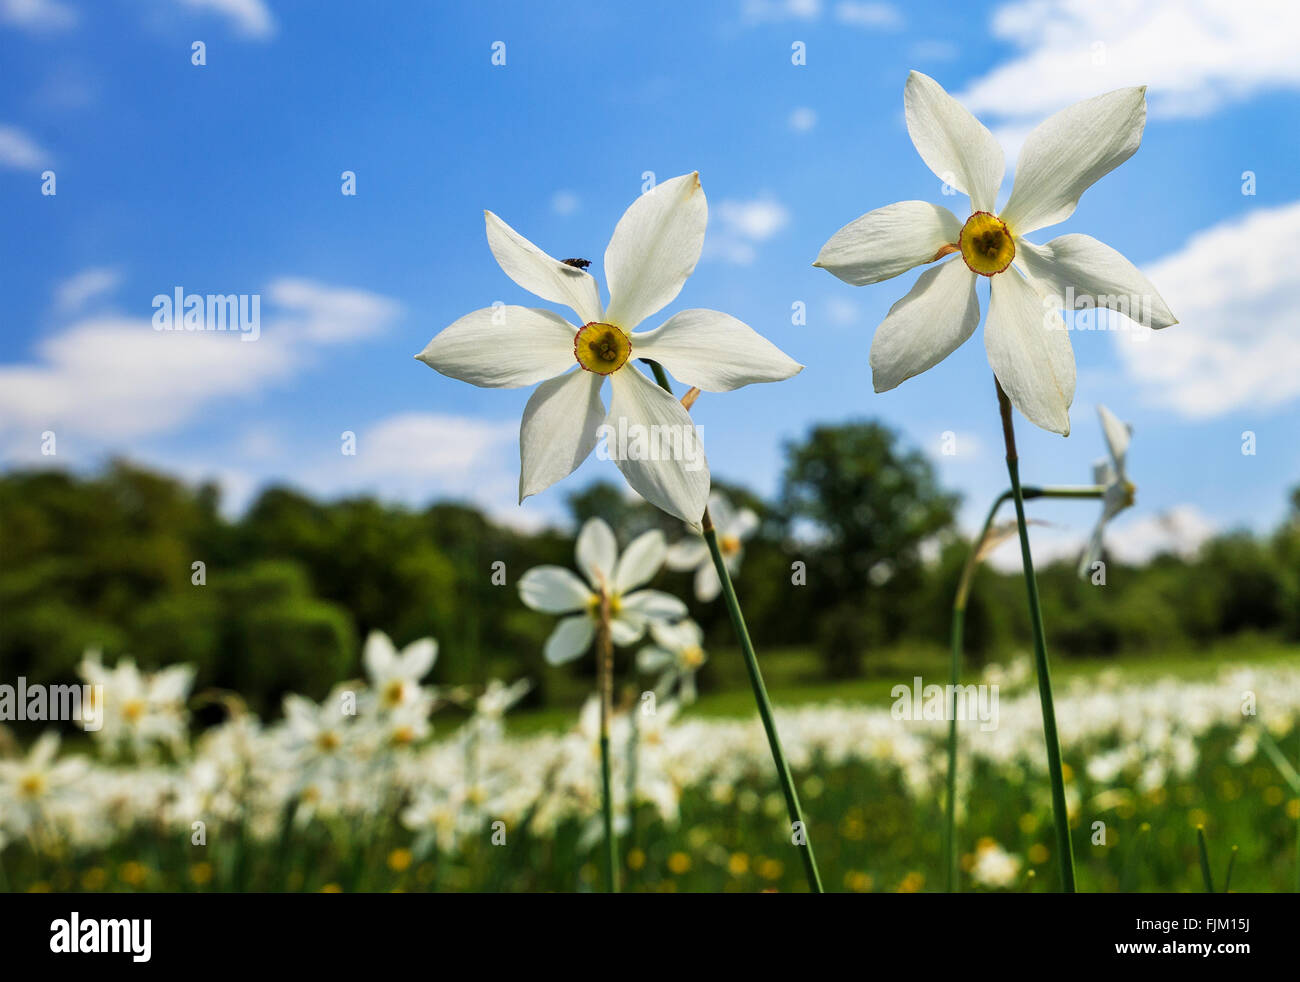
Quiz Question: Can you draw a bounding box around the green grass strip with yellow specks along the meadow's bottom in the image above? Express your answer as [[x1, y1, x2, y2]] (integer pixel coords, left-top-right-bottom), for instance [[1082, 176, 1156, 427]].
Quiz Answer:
[[0, 728, 1300, 892]]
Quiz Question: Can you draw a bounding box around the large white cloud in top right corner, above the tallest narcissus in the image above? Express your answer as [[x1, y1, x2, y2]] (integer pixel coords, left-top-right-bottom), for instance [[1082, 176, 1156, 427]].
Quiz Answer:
[[957, 0, 1300, 126]]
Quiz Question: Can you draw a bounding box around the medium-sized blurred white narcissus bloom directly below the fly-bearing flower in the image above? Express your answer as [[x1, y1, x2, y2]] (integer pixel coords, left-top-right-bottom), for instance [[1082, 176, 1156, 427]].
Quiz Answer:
[[519, 518, 686, 665]]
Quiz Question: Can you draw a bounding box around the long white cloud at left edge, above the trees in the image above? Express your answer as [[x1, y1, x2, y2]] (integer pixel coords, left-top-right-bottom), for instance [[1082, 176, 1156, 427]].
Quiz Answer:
[[0, 280, 399, 457]]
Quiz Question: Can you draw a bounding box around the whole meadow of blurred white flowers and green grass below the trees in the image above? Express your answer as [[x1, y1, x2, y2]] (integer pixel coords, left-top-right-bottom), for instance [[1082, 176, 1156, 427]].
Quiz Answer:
[[0, 633, 1300, 891]]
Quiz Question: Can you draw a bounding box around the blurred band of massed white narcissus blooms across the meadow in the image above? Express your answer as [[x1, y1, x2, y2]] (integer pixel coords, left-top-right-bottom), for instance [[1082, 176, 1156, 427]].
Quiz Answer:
[[0, 650, 1300, 874]]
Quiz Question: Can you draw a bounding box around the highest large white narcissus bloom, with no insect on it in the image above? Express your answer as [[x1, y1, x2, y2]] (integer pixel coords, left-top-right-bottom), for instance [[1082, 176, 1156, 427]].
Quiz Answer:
[[815, 72, 1178, 436]]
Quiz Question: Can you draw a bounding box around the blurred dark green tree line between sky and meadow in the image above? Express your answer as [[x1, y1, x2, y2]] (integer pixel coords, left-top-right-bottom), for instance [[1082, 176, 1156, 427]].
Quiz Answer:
[[0, 421, 1300, 711]]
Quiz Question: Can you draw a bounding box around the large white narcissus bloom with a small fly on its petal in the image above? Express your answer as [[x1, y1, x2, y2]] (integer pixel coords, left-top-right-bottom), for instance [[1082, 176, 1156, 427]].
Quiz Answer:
[[416, 173, 802, 524]]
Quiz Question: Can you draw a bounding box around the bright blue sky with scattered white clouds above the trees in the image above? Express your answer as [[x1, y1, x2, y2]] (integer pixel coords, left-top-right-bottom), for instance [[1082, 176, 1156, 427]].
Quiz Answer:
[[0, 0, 1300, 558]]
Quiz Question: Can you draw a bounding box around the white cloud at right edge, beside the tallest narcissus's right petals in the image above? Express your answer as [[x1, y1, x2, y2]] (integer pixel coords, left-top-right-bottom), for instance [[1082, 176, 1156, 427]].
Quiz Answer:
[[1115, 202, 1300, 418]]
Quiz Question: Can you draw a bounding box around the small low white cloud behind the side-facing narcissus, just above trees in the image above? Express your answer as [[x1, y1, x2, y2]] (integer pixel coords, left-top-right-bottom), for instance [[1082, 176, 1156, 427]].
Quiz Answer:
[[988, 507, 1218, 572]]
